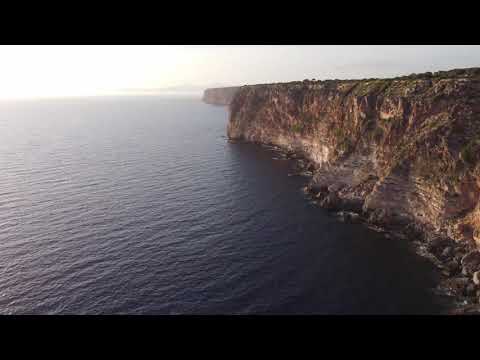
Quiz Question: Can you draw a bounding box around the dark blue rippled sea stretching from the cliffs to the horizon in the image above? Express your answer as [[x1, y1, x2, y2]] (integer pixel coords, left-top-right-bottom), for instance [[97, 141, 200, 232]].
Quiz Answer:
[[0, 96, 440, 314]]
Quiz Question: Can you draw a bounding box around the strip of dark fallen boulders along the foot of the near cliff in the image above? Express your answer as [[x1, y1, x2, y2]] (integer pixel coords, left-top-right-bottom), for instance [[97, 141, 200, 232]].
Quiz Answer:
[[256, 141, 480, 315]]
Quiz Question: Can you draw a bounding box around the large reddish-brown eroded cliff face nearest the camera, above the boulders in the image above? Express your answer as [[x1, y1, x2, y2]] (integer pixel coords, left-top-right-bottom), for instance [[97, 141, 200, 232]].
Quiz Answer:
[[227, 68, 480, 246]]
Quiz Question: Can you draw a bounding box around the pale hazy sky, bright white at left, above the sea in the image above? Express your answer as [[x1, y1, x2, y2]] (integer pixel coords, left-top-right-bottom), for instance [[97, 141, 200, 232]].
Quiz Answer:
[[0, 45, 480, 98]]
